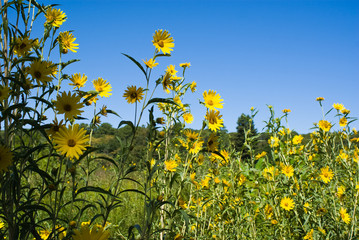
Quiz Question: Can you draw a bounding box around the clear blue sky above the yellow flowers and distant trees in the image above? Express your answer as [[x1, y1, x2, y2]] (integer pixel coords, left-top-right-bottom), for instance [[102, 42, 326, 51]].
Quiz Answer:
[[40, 0, 359, 133]]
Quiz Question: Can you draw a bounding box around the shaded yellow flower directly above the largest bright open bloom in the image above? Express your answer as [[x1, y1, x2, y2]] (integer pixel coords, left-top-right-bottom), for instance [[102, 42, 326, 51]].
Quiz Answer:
[[55, 91, 84, 120]]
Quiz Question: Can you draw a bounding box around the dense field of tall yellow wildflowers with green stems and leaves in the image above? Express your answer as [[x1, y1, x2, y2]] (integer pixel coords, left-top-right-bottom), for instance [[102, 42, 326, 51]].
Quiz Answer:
[[0, 0, 359, 240]]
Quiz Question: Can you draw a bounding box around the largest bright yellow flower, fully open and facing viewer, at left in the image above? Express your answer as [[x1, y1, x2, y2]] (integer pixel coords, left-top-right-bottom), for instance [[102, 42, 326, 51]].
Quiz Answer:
[[54, 124, 89, 159]]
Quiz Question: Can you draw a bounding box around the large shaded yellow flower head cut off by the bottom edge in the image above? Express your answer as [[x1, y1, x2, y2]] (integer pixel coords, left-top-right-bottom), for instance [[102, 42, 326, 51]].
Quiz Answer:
[[72, 224, 110, 240]]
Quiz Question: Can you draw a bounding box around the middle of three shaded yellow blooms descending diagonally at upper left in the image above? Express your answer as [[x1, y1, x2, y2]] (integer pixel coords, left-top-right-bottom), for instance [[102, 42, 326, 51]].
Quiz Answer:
[[28, 60, 52, 85]]
